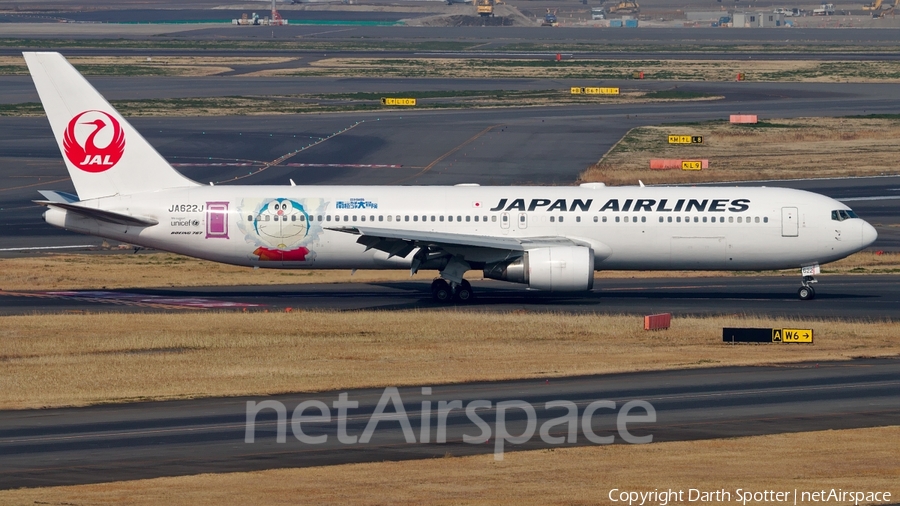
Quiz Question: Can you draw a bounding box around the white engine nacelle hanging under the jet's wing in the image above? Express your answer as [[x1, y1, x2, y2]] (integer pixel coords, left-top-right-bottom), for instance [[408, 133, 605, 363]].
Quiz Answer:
[[484, 246, 594, 292]]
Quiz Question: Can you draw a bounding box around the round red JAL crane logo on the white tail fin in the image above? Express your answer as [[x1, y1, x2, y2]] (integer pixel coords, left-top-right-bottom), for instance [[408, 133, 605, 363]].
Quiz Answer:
[[63, 110, 125, 172]]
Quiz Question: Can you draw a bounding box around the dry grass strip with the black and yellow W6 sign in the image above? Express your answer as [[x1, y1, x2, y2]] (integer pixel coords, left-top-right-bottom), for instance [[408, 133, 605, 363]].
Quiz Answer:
[[0, 310, 900, 409]]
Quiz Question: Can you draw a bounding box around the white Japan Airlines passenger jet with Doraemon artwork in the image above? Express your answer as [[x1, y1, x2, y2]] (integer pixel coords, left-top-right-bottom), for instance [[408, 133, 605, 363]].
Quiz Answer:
[[24, 52, 877, 302]]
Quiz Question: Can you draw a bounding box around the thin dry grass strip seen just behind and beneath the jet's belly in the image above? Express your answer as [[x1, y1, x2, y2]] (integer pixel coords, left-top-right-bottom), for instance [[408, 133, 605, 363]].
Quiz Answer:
[[0, 251, 900, 292]]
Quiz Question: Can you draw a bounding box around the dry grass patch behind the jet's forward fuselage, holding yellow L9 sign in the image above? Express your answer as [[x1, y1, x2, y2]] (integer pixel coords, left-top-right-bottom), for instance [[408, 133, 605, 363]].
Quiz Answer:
[[581, 116, 900, 185]]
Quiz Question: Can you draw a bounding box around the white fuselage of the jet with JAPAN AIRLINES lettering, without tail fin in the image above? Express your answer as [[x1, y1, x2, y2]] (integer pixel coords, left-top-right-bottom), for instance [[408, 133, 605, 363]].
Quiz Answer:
[[45, 185, 876, 270]]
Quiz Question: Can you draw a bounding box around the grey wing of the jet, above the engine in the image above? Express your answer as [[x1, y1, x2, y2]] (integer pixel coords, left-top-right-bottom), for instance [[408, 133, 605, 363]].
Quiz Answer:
[[329, 227, 579, 257]]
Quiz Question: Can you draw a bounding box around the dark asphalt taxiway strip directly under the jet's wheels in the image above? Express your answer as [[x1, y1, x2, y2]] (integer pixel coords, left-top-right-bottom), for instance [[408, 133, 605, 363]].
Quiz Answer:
[[0, 272, 900, 320]]
